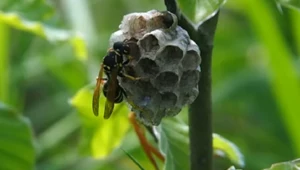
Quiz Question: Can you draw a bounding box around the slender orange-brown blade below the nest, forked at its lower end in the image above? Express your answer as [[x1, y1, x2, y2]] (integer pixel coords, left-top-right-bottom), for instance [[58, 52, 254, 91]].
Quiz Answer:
[[129, 112, 165, 170]]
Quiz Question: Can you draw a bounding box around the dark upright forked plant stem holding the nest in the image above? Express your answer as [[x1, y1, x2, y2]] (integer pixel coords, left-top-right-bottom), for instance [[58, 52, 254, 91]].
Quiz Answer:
[[165, 0, 219, 170]]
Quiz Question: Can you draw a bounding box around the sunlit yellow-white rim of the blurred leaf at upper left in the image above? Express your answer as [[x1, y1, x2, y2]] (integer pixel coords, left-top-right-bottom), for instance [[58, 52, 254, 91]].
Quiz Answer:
[[0, 11, 87, 60]]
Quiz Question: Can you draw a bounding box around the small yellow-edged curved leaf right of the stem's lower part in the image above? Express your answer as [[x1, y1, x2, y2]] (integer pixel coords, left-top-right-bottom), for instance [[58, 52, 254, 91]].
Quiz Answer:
[[213, 134, 245, 167]]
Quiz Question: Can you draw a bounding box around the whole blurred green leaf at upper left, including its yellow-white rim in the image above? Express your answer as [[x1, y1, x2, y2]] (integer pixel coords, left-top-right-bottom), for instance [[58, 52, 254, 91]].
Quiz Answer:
[[0, 0, 88, 60]]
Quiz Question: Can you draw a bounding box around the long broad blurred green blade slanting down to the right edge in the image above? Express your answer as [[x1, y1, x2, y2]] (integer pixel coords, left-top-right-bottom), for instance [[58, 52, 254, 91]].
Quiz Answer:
[[243, 0, 300, 155]]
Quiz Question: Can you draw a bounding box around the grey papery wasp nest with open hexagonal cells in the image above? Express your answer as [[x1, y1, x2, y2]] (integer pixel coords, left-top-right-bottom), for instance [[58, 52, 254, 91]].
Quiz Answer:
[[110, 10, 201, 125]]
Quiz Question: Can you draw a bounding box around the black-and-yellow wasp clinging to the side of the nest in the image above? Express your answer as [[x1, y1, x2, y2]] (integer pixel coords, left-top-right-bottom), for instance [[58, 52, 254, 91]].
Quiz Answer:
[[92, 40, 139, 119]]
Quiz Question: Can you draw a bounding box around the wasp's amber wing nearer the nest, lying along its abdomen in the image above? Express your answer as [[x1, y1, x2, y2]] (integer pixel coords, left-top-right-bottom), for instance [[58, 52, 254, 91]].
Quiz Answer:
[[104, 66, 119, 119]]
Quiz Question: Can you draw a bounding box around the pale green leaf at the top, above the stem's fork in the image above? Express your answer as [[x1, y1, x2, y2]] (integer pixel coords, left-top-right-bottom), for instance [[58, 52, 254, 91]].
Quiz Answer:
[[178, 0, 226, 27]]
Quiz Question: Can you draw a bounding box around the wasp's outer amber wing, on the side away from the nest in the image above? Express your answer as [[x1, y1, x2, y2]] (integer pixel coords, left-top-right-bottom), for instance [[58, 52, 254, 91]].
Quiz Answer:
[[93, 64, 104, 116]]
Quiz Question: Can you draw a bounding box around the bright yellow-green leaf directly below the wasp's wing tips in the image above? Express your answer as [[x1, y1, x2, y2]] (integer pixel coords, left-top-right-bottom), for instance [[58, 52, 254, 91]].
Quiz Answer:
[[71, 86, 129, 158]]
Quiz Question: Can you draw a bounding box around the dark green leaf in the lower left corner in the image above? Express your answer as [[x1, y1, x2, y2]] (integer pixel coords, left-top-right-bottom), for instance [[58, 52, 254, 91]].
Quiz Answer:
[[0, 102, 35, 170]]
